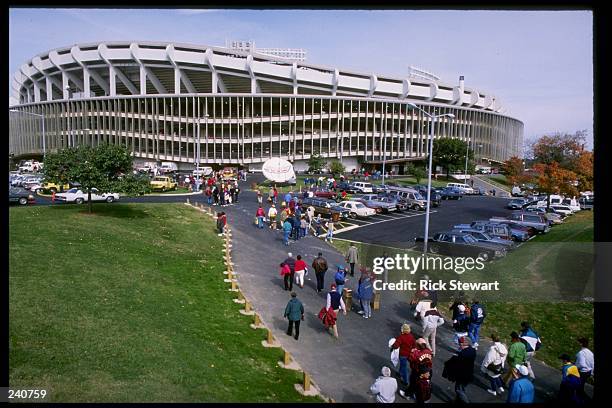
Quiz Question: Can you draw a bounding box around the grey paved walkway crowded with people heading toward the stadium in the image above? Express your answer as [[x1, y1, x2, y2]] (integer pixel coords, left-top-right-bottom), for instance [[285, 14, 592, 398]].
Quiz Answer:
[[195, 180, 592, 402]]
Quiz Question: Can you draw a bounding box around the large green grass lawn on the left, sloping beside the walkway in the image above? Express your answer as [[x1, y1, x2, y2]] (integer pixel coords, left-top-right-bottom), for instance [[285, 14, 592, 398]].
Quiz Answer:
[[9, 204, 318, 402]]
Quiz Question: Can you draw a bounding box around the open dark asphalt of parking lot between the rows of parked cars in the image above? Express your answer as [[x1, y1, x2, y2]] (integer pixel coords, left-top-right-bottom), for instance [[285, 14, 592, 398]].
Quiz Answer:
[[334, 196, 511, 248]]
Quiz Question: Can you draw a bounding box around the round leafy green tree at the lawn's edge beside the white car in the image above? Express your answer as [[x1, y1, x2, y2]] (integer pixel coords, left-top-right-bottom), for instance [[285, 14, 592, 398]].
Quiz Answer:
[[44, 144, 148, 213]]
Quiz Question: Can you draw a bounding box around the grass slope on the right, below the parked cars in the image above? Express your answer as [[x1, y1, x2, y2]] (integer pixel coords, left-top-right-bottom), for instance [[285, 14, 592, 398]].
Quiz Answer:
[[334, 211, 594, 366]]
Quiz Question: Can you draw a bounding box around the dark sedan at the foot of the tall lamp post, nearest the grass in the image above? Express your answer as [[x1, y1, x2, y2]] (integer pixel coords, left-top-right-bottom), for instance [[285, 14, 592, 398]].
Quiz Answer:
[[415, 231, 506, 262]]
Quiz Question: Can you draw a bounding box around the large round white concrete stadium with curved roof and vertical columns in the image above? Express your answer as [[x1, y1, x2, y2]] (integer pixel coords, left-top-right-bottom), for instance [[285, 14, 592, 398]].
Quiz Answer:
[[9, 41, 523, 171]]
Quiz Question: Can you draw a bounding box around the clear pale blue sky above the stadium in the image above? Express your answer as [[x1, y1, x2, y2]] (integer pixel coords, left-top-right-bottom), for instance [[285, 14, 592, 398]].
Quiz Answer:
[[9, 9, 593, 147]]
